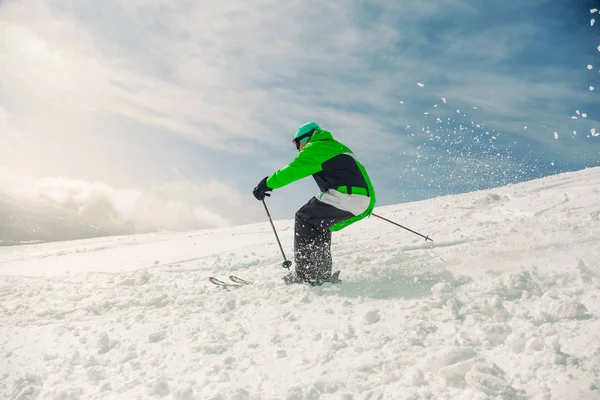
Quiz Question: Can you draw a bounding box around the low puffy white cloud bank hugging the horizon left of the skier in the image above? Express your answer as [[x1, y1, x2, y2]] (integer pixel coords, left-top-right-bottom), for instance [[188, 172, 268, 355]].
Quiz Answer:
[[0, 167, 254, 238]]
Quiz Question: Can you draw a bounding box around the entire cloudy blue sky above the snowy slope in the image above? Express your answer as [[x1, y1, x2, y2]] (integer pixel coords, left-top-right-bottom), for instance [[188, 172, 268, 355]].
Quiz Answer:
[[0, 0, 600, 236]]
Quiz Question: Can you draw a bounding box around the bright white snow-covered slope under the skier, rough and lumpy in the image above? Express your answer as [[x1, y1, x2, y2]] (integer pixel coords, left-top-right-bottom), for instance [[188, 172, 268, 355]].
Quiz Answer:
[[0, 168, 600, 400]]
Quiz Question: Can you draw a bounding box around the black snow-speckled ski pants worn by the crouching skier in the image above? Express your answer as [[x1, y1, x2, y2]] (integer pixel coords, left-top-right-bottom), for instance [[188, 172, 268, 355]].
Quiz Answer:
[[294, 197, 354, 281]]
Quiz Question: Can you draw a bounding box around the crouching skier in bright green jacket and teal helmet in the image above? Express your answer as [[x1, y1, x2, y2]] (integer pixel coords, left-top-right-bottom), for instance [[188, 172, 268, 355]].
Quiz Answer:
[[253, 122, 376, 285]]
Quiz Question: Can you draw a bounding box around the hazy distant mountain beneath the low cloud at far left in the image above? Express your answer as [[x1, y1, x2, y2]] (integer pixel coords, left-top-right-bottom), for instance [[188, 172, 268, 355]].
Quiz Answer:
[[0, 192, 133, 246]]
